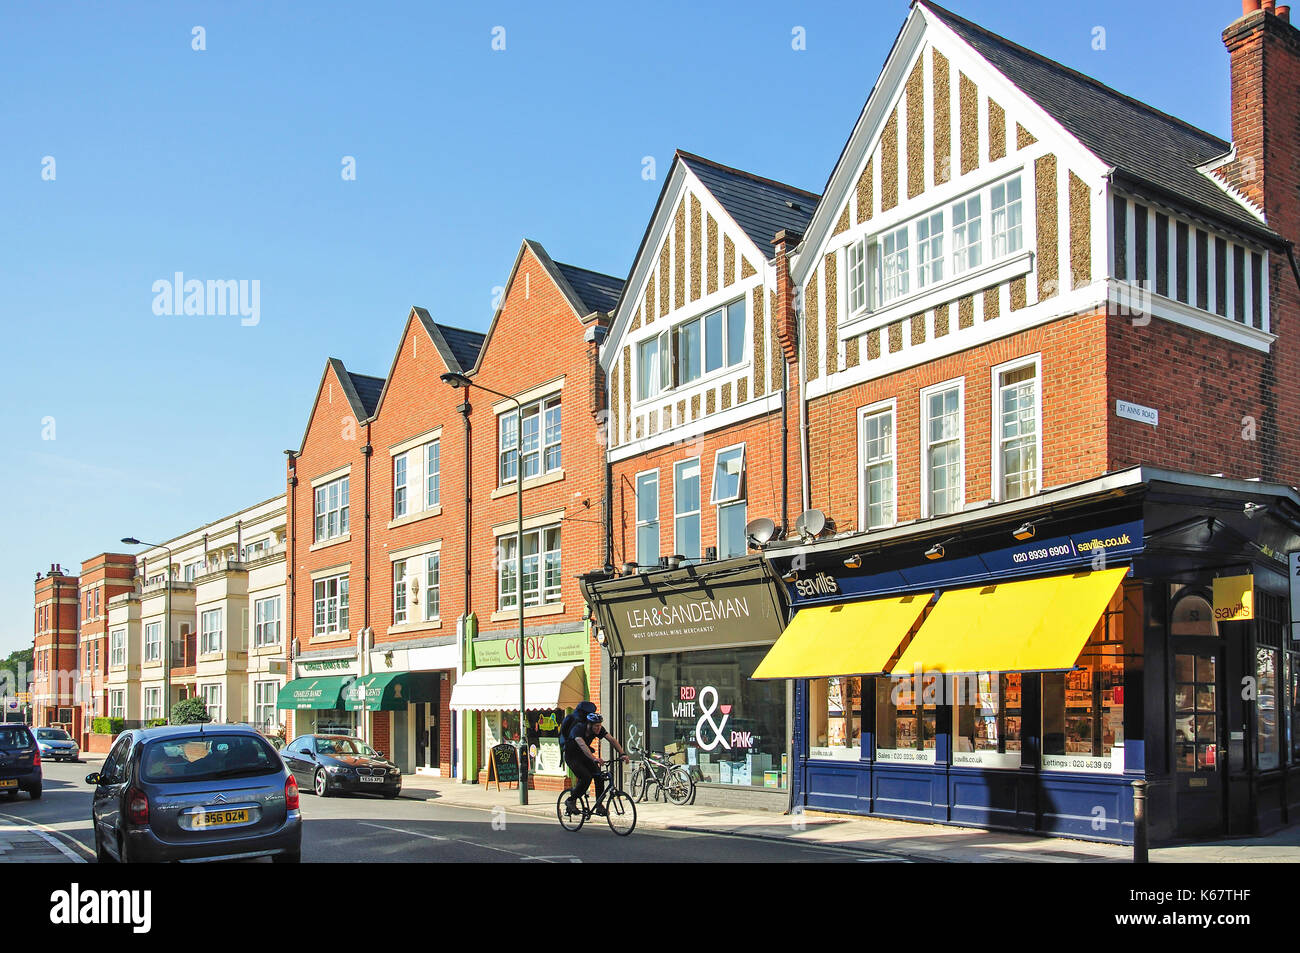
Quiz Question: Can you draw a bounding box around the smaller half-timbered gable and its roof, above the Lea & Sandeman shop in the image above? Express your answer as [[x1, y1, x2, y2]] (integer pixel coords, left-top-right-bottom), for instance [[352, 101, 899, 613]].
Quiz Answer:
[[601, 152, 818, 460]]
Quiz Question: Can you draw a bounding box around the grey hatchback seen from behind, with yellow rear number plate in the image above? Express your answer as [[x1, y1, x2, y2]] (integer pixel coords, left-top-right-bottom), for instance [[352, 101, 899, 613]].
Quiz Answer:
[[86, 724, 303, 863]]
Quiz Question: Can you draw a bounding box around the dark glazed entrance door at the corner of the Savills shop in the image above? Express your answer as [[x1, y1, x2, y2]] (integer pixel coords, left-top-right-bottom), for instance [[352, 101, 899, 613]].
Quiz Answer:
[[1173, 642, 1227, 837]]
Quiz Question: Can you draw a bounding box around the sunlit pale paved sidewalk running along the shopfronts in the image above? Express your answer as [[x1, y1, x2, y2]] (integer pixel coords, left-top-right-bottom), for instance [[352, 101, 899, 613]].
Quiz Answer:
[[402, 775, 1300, 863]]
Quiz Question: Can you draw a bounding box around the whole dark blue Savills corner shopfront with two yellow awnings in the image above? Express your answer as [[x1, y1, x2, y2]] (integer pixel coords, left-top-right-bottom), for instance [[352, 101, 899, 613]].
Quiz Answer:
[[754, 468, 1300, 842]]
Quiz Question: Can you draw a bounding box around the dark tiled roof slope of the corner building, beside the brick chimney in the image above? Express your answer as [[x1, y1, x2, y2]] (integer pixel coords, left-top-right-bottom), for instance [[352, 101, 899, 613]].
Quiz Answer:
[[922, 0, 1271, 234]]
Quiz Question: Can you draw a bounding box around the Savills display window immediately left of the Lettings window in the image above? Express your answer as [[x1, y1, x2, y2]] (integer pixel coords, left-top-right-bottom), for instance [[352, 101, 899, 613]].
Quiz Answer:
[[953, 672, 1022, 768]]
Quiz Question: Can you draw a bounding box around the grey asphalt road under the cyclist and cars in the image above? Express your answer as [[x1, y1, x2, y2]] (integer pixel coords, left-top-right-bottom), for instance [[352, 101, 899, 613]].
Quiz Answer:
[[0, 759, 898, 863]]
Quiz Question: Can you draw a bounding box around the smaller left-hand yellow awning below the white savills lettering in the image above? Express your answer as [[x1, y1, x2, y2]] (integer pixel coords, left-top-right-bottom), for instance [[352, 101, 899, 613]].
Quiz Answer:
[[753, 593, 933, 679]]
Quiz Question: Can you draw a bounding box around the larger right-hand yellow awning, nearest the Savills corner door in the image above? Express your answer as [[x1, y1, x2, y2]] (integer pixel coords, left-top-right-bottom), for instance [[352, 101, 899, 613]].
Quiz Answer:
[[893, 567, 1128, 675]]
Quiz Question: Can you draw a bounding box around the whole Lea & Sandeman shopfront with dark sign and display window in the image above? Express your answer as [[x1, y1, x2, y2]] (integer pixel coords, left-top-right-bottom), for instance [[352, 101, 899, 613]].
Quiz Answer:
[[582, 555, 792, 810]]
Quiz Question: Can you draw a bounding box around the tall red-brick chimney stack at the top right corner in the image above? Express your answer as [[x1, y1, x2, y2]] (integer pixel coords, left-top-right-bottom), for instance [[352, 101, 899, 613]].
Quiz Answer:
[[1218, 0, 1300, 234]]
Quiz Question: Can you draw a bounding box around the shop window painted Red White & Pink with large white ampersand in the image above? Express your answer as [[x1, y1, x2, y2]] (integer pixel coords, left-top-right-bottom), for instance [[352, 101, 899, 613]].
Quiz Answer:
[[645, 646, 789, 788]]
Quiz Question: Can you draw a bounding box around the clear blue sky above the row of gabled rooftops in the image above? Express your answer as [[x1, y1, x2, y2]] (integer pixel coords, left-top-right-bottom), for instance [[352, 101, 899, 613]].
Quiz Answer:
[[0, 0, 1242, 655]]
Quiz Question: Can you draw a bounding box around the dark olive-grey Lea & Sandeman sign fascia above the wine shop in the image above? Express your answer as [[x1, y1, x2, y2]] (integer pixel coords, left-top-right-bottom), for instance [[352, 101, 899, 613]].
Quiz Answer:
[[584, 558, 785, 654]]
